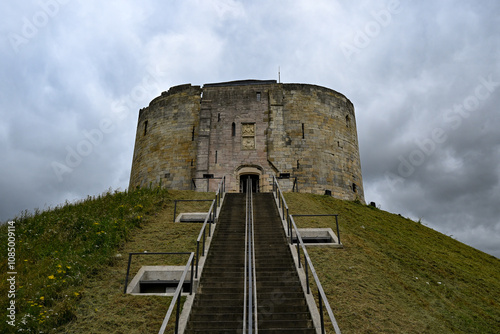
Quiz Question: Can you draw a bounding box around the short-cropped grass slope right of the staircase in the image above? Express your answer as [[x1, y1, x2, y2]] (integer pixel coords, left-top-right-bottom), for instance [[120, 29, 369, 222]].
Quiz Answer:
[[285, 193, 500, 333]]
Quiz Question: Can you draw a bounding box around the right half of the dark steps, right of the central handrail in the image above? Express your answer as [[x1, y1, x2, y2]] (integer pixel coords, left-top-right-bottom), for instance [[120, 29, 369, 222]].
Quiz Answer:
[[254, 193, 316, 333]]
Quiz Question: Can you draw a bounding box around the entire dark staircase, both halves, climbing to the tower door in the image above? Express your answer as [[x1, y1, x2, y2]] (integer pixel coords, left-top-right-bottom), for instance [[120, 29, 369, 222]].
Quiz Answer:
[[184, 193, 316, 333]]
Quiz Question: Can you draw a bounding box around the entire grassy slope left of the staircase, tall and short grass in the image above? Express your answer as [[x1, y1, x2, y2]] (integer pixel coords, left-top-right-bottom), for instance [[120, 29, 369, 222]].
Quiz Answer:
[[0, 189, 213, 333]]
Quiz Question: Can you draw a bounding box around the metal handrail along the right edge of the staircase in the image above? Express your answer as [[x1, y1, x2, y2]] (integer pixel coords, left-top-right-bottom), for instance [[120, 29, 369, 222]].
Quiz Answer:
[[273, 176, 340, 334]]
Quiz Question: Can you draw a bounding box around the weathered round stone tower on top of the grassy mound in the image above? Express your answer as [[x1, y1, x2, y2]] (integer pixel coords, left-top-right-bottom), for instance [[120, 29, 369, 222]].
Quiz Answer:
[[130, 80, 364, 200]]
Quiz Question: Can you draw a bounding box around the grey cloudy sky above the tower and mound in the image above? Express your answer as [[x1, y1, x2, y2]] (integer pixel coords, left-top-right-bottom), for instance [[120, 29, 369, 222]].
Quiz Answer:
[[0, 0, 500, 257]]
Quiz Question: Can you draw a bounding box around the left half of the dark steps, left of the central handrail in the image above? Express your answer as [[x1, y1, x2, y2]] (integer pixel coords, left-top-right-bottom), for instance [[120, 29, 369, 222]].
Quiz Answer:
[[184, 194, 245, 333]]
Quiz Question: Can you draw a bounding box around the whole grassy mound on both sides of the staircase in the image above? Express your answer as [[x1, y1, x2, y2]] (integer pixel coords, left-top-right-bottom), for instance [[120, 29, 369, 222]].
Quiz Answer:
[[0, 189, 500, 333]]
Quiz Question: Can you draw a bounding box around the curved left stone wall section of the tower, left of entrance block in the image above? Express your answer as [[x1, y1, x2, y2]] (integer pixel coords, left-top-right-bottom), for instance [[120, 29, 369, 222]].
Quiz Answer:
[[130, 85, 201, 189]]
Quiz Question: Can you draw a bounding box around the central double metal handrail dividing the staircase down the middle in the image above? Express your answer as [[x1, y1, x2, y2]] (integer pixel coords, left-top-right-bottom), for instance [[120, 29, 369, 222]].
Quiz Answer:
[[243, 178, 258, 333]]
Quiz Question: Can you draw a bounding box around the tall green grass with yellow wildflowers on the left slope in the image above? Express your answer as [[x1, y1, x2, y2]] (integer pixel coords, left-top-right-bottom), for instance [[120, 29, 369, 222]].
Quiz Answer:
[[0, 189, 169, 333]]
